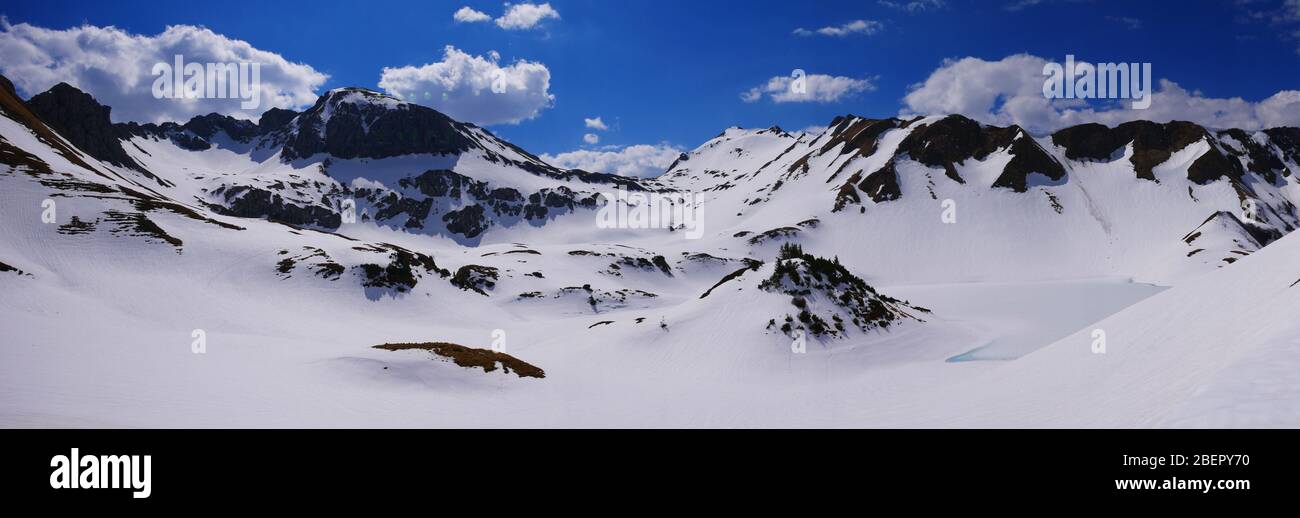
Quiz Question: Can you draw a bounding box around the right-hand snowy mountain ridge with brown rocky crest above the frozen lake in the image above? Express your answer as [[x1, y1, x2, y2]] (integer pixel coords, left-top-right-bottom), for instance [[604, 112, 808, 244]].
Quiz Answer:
[[657, 116, 1300, 282]]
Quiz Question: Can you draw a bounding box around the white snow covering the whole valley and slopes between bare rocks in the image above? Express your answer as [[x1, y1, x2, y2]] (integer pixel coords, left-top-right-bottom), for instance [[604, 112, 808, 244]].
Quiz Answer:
[[0, 99, 1300, 427]]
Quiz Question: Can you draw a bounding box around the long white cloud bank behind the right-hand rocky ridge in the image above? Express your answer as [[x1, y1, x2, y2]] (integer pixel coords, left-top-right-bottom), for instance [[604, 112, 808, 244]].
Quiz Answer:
[[901, 53, 1300, 134]]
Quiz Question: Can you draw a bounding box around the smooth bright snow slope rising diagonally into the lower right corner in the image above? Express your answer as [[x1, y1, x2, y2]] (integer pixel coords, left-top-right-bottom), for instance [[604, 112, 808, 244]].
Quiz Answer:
[[920, 227, 1300, 428]]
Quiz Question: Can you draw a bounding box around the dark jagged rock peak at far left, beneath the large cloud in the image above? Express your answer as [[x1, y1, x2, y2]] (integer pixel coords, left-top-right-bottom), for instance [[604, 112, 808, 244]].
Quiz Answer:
[[25, 79, 142, 169]]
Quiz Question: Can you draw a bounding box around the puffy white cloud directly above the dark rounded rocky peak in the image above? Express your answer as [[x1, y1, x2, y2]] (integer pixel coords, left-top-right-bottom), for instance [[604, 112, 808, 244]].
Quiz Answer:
[[380, 46, 555, 125]]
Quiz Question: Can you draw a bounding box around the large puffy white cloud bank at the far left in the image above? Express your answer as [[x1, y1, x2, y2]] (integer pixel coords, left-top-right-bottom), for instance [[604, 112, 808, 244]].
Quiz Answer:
[[0, 18, 328, 122]]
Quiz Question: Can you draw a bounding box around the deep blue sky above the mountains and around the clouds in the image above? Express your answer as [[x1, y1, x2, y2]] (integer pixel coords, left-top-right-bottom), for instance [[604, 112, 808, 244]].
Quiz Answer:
[[0, 0, 1300, 162]]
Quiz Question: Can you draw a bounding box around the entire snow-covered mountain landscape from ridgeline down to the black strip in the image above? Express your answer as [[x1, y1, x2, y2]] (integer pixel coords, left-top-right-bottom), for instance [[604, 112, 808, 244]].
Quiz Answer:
[[0, 75, 1300, 426]]
